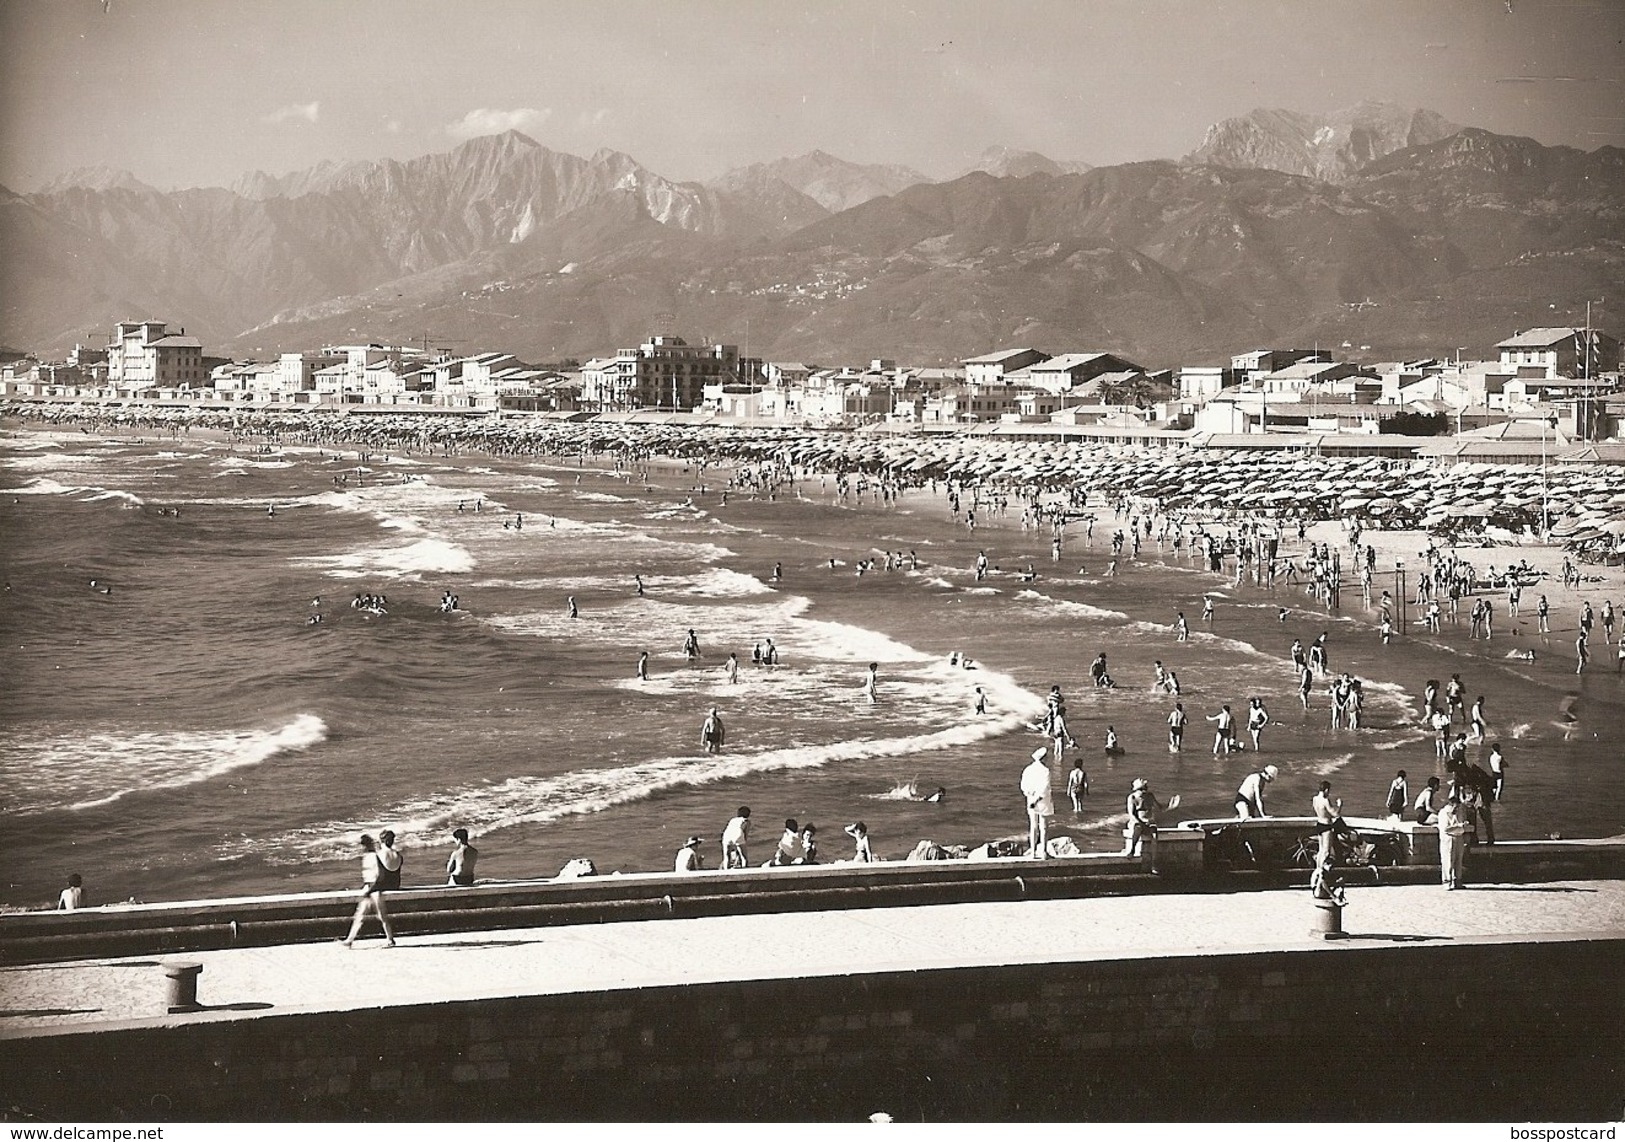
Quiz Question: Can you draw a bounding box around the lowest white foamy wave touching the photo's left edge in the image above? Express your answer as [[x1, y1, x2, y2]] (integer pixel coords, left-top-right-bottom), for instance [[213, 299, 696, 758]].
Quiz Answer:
[[0, 713, 327, 812]]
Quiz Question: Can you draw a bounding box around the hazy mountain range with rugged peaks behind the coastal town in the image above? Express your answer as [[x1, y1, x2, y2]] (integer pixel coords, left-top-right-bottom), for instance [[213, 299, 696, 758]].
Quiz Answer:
[[0, 104, 1625, 366]]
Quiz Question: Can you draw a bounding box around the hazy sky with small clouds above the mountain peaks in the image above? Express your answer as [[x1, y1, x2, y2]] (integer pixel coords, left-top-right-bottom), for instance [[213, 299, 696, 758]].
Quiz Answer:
[[0, 0, 1625, 190]]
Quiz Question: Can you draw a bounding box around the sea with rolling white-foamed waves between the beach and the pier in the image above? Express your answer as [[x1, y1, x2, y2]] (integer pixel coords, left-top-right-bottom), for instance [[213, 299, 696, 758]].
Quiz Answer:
[[0, 429, 1625, 908]]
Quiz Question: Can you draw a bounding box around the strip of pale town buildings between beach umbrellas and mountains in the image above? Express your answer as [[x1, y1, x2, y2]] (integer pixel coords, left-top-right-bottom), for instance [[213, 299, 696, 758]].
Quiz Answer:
[[0, 314, 1625, 463]]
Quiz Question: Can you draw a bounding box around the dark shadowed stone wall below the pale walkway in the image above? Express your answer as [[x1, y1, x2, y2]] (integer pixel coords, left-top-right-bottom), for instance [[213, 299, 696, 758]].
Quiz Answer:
[[0, 936, 1625, 1121]]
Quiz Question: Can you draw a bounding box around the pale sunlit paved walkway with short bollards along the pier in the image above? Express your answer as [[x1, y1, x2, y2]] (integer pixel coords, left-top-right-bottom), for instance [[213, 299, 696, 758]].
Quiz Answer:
[[0, 880, 1625, 1036]]
